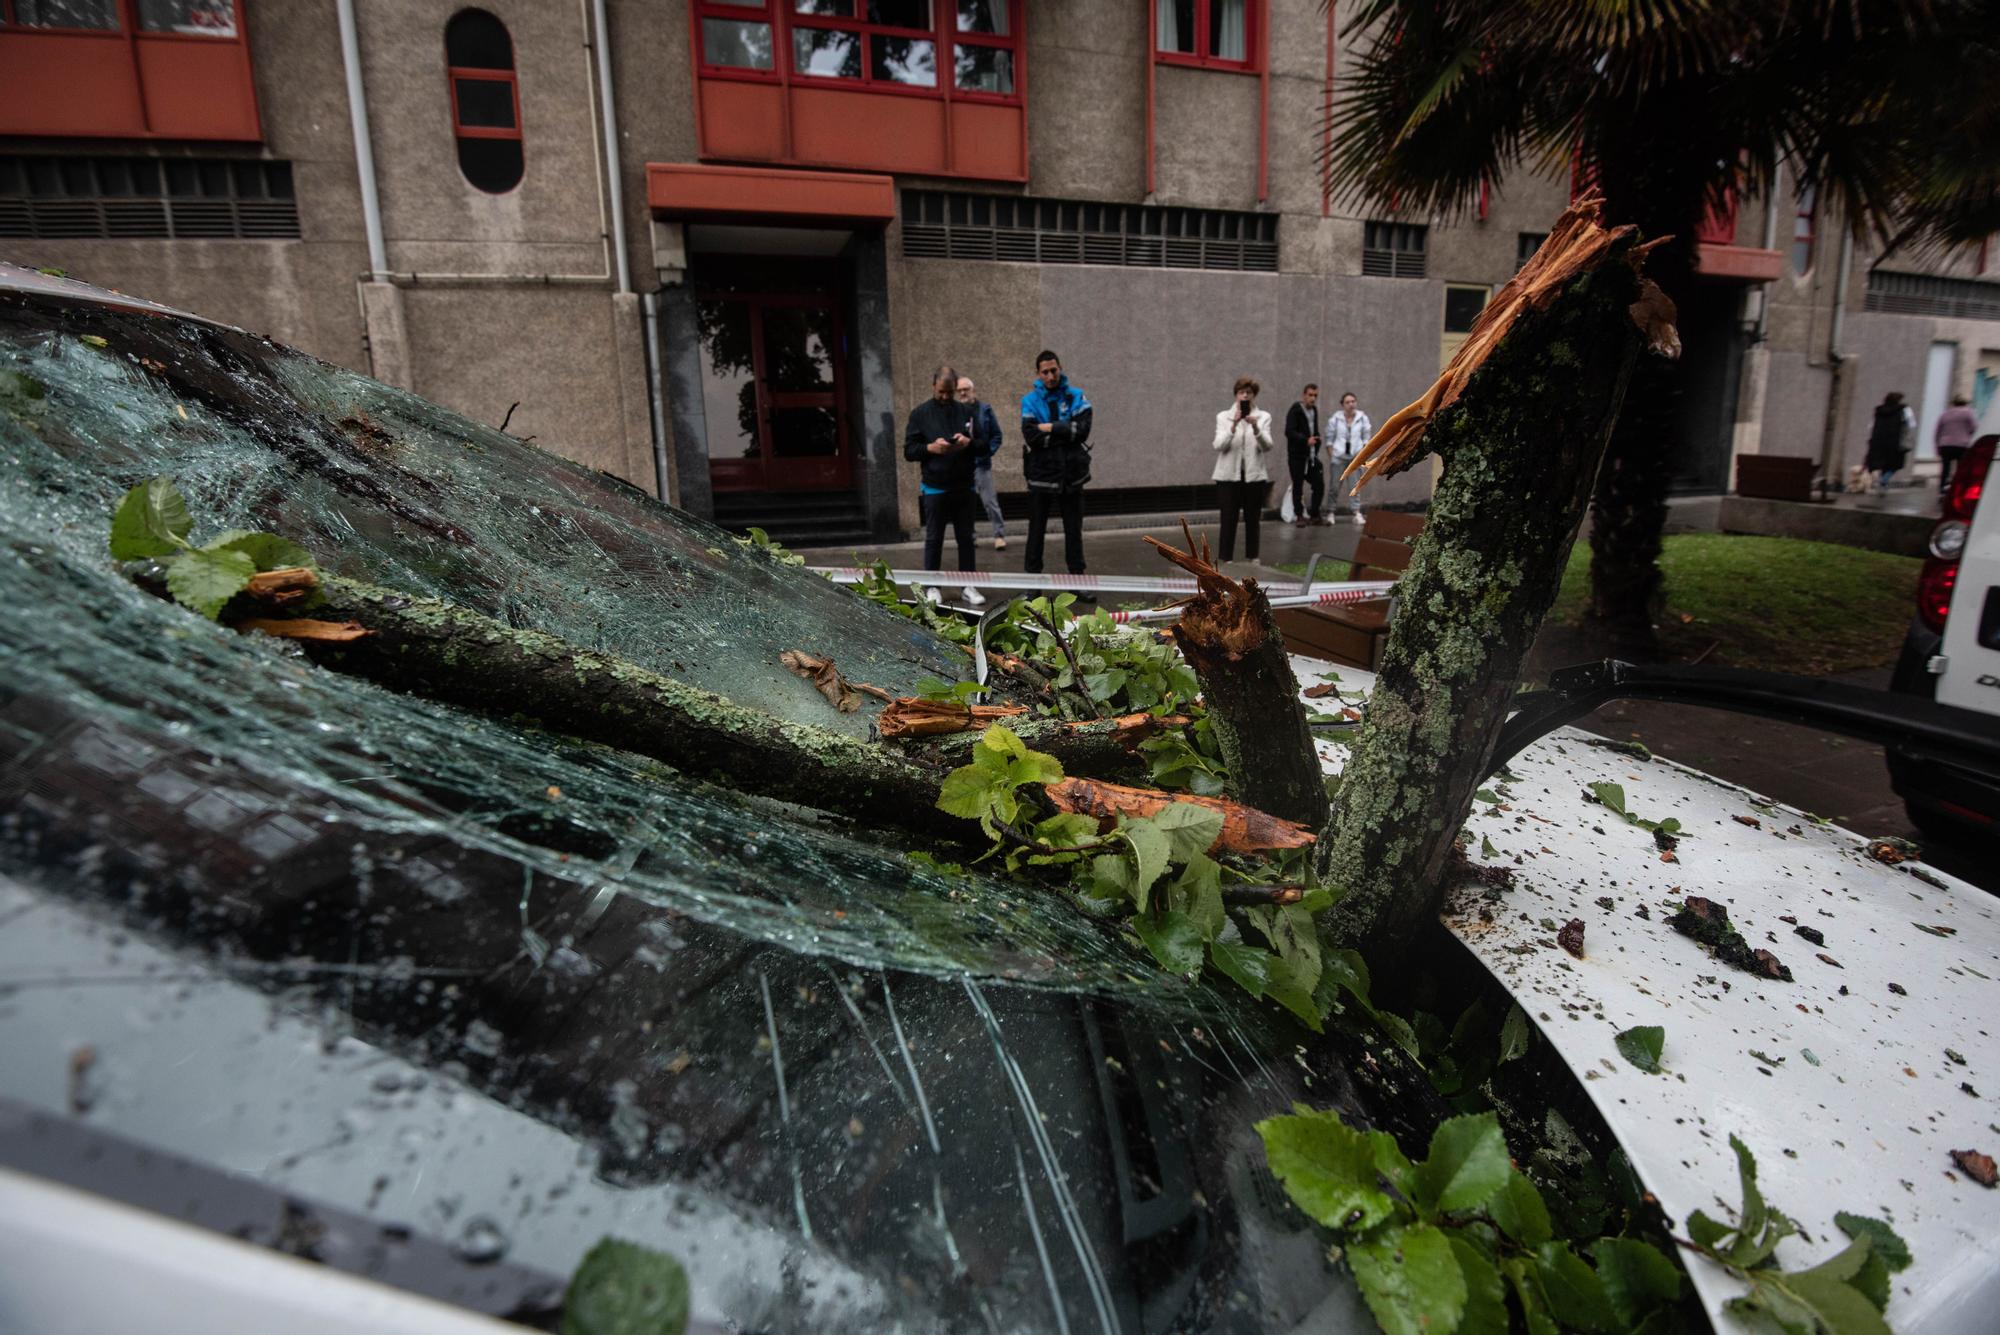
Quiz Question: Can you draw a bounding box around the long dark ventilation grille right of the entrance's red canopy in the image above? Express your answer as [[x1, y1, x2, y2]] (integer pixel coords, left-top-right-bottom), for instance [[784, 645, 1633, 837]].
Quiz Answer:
[[902, 190, 1278, 274]]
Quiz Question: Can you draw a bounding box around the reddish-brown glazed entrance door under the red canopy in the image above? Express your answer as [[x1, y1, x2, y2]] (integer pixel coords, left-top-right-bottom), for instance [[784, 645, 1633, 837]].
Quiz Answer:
[[694, 290, 854, 492]]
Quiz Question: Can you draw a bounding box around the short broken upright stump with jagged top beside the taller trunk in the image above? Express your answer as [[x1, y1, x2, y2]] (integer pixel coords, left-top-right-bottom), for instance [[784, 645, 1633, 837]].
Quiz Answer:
[[1146, 534, 1326, 829]]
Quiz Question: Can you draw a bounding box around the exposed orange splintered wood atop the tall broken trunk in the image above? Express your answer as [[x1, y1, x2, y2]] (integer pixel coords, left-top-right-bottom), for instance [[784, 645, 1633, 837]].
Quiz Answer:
[[1340, 194, 1680, 492]]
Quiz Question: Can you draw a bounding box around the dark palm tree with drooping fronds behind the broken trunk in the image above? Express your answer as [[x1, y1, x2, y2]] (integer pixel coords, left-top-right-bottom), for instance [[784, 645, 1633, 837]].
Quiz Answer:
[[1326, 0, 2000, 650]]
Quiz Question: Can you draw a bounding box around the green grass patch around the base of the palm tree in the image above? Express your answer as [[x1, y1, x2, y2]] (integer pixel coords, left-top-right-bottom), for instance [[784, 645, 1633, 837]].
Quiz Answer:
[[1550, 534, 1922, 675]]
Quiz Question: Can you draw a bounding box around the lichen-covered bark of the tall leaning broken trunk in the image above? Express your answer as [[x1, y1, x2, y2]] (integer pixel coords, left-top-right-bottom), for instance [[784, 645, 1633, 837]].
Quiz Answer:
[[1320, 252, 1640, 957]]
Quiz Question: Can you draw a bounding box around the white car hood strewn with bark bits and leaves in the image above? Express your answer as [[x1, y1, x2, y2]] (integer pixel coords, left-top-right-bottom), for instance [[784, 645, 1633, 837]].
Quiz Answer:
[[1294, 658, 2000, 1335]]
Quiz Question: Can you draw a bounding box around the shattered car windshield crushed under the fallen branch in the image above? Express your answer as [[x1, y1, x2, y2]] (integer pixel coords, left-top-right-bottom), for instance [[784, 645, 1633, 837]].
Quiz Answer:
[[0, 296, 1388, 1331]]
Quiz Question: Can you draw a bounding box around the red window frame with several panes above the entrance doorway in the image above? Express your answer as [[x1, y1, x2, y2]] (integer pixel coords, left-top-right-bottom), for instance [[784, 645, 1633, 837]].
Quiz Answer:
[[692, 0, 1026, 106]]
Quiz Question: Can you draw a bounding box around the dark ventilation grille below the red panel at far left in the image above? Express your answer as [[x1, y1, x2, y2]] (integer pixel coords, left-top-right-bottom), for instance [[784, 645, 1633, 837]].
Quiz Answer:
[[0, 154, 298, 242]]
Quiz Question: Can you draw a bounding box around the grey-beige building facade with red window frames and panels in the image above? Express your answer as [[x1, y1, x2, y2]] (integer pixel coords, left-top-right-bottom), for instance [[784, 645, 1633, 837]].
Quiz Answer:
[[0, 0, 2000, 542]]
